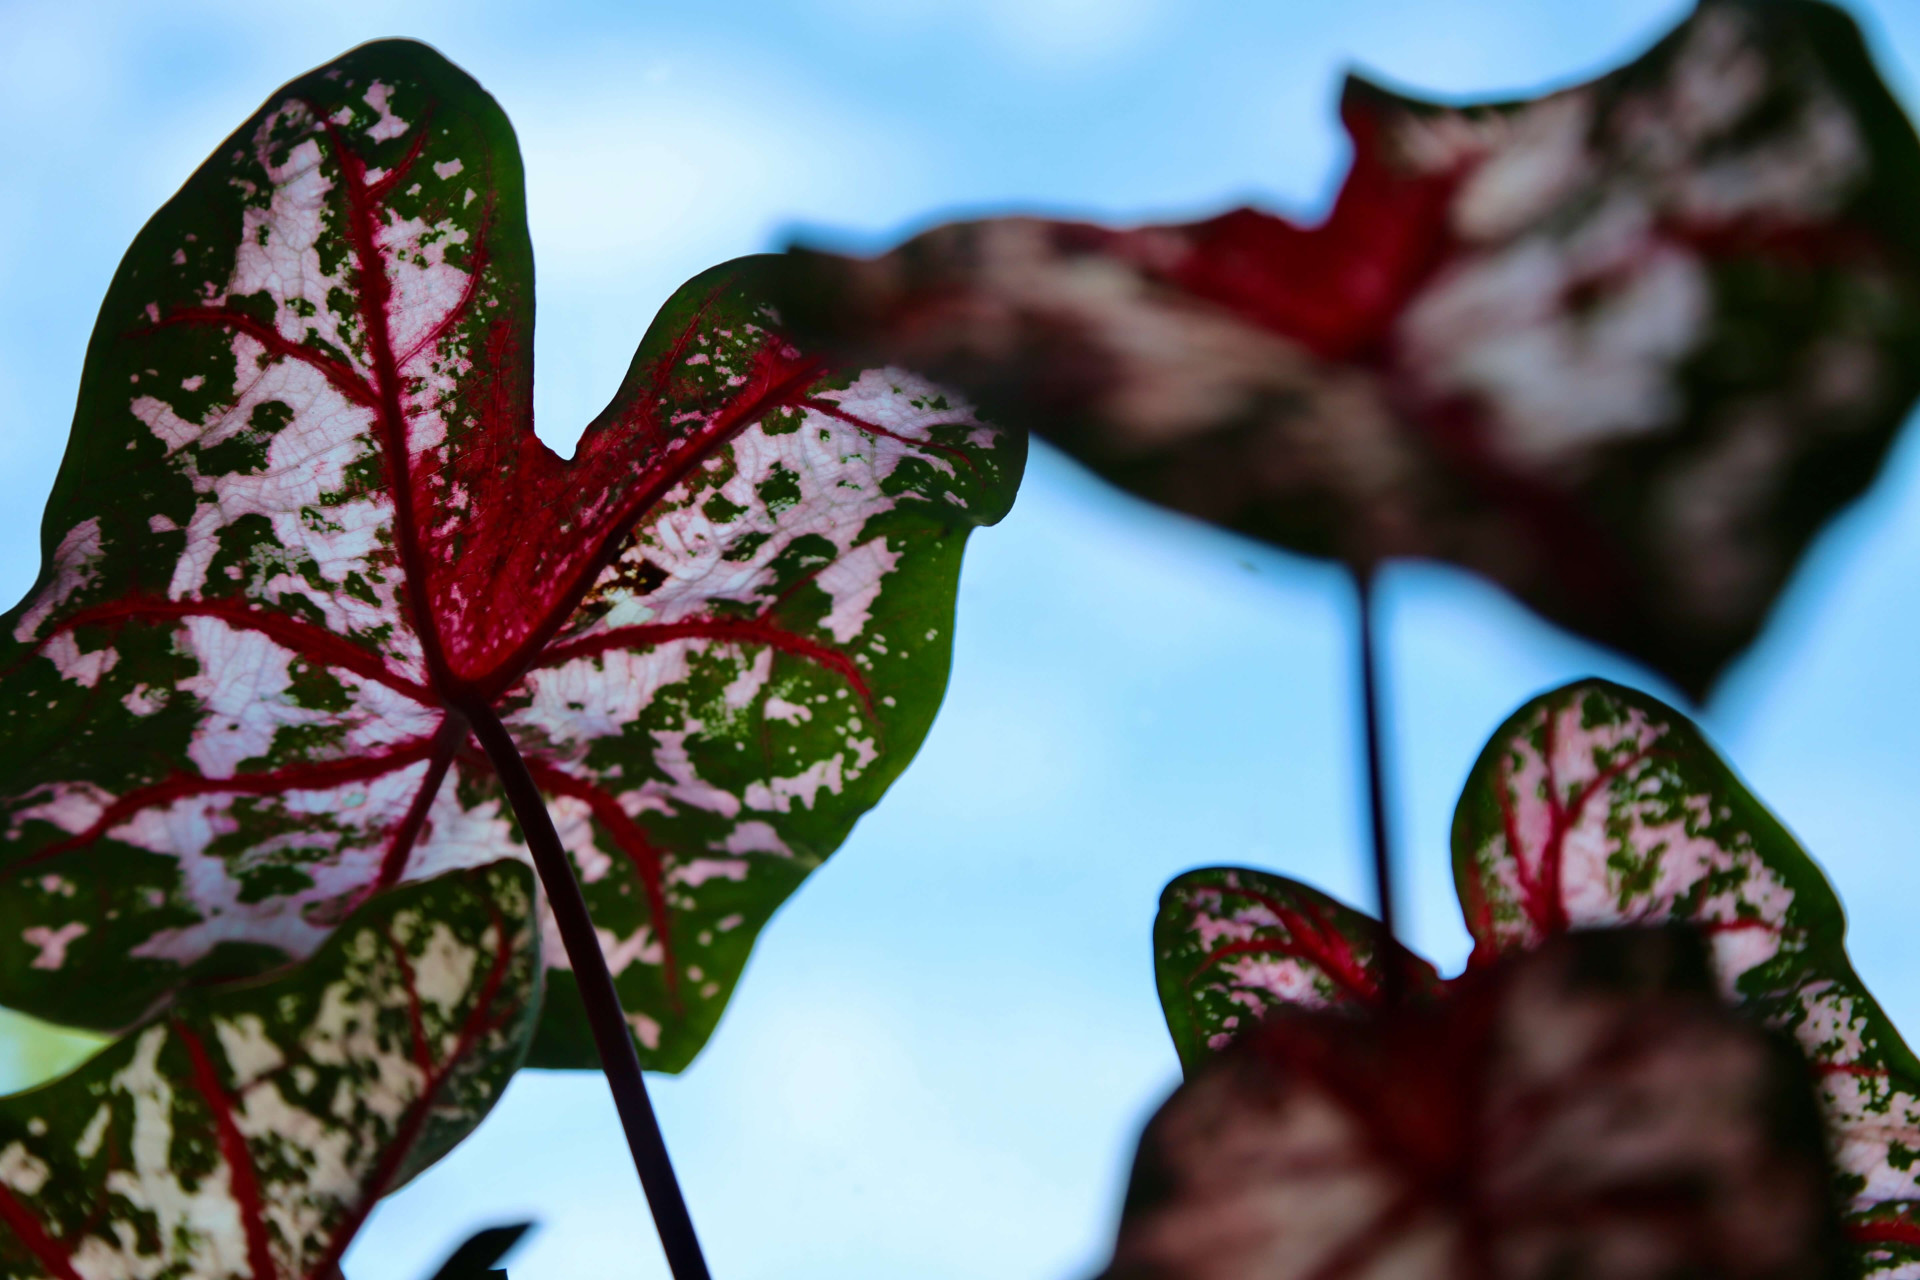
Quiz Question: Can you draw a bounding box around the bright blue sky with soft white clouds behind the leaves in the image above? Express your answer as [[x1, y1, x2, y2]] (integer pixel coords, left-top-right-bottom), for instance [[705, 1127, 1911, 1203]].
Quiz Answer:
[[0, 0, 1920, 1280]]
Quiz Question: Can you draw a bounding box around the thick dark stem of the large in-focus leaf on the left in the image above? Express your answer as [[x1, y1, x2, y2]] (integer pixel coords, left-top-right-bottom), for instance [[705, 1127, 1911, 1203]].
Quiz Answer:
[[459, 699, 708, 1280]]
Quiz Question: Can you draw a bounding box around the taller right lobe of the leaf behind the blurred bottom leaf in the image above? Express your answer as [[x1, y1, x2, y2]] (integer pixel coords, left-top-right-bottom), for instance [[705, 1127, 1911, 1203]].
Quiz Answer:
[[1453, 679, 1920, 1274]]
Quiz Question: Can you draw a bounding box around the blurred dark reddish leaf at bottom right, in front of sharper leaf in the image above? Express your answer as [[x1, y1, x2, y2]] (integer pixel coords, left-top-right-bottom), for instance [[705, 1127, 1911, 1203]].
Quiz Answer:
[[1106, 931, 1845, 1280]]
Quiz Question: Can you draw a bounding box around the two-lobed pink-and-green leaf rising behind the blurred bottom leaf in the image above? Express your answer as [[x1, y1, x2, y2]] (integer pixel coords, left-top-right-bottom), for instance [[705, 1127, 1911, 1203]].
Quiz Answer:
[[1154, 679, 1920, 1278]]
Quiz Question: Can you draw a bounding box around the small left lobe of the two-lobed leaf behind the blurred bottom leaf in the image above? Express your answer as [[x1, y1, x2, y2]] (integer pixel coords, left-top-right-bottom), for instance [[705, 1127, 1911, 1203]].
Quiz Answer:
[[1154, 867, 1440, 1073]]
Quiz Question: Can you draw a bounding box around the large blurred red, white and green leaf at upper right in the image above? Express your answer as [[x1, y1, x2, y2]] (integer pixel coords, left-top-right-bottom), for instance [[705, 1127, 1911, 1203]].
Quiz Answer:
[[789, 0, 1920, 695]]
